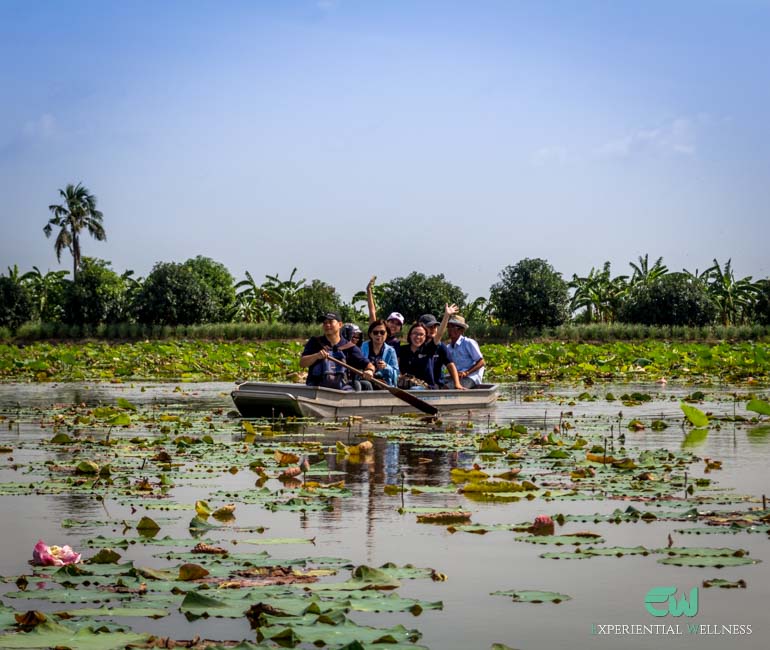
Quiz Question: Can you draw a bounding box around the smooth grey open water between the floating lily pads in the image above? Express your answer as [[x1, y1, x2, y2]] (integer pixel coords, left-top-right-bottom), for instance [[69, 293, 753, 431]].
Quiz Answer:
[[0, 384, 770, 650]]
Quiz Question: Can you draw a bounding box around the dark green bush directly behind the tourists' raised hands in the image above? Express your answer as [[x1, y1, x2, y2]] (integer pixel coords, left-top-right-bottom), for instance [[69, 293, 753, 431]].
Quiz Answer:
[[377, 271, 467, 323]]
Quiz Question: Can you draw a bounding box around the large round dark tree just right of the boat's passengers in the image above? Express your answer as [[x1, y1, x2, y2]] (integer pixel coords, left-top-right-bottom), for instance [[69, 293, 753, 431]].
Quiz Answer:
[[490, 259, 569, 328]]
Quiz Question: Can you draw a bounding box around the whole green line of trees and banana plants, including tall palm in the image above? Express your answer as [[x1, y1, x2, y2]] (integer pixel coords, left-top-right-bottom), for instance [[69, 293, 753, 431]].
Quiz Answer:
[[0, 184, 770, 332]]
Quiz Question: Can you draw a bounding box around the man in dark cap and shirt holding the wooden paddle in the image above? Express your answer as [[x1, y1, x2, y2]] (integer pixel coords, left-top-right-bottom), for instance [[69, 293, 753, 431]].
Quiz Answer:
[[299, 312, 375, 390]]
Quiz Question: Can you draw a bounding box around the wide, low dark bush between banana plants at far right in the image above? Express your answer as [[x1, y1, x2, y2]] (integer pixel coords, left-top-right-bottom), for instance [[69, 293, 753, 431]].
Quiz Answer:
[[619, 273, 717, 326]]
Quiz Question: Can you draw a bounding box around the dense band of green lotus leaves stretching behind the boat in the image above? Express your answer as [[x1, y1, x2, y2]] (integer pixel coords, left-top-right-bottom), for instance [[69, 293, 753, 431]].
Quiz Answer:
[[0, 339, 770, 382]]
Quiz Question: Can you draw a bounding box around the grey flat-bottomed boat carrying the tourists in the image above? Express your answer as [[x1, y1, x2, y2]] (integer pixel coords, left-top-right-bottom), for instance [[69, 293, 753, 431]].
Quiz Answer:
[[230, 381, 497, 418]]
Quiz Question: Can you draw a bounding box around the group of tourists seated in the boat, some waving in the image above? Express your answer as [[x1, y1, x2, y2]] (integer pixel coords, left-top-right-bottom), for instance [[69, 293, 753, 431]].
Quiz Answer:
[[299, 278, 484, 390]]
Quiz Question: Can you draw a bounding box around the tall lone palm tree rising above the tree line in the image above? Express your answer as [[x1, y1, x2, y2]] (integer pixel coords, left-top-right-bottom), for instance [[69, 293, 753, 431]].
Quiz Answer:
[[43, 183, 107, 280]]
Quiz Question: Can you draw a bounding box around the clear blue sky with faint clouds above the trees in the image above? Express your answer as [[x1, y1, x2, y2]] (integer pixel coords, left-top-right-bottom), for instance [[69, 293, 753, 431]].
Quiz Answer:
[[0, 0, 770, 300]]
